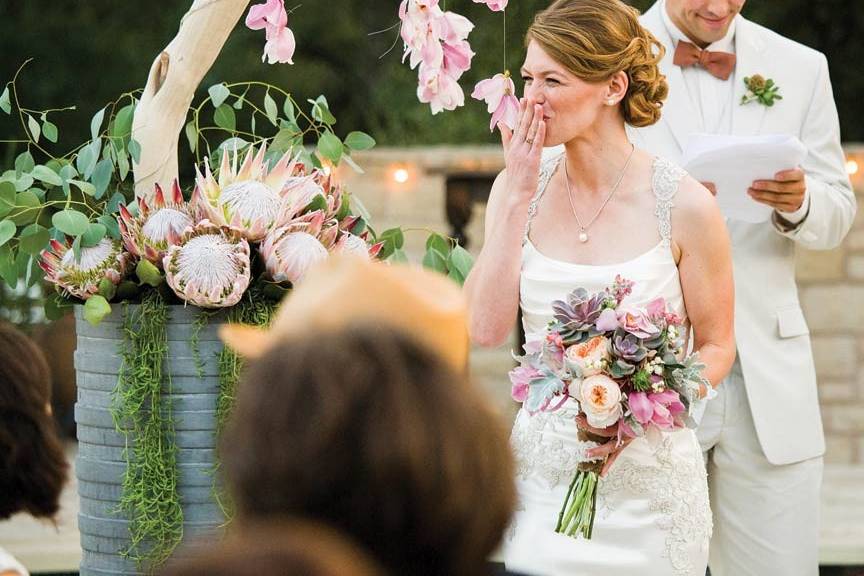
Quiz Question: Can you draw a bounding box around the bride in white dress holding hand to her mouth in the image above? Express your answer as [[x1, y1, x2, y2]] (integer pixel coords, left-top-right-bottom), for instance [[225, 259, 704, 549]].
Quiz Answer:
[[466, 0, 735, 576]]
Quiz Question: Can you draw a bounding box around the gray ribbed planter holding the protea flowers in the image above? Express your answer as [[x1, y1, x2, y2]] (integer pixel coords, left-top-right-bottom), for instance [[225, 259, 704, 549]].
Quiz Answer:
[[75, 305, 230, 576]]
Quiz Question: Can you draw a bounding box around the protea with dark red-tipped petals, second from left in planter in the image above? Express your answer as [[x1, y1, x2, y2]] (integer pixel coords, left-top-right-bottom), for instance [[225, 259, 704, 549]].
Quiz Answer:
[[118, 180, 199, 268]]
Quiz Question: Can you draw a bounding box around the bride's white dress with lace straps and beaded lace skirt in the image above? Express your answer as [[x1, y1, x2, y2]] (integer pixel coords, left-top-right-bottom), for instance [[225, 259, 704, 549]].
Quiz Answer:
[[503, 156, 711, 576]]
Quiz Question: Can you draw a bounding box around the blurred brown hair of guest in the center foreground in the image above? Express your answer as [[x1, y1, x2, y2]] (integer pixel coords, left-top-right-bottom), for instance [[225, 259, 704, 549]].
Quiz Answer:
[[222, 325, 515, 576]]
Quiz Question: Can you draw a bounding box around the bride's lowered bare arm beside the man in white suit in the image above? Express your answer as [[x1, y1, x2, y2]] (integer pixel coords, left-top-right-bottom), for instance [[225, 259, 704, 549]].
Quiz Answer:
[[672, 177, 735, 387]]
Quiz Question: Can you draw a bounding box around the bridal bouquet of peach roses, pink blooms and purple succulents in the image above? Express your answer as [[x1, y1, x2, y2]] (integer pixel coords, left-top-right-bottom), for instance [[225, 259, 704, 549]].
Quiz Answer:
[[510, 276, 710, 539]]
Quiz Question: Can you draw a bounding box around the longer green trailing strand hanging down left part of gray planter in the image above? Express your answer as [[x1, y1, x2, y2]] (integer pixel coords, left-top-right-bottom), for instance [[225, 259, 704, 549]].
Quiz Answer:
[[110, 291, 183, 569]]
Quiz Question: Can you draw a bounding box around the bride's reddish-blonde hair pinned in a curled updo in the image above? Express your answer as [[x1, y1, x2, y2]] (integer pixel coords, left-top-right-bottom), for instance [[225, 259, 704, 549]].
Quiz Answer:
[[525, 0, 669, 127]]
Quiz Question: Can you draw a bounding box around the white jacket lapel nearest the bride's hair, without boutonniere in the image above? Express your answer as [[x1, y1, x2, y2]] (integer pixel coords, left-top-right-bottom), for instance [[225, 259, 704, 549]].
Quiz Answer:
[[642, 2, 703, 151]]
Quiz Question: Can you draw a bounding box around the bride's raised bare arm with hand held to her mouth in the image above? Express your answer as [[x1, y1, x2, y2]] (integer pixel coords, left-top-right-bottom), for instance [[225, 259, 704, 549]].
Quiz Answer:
[[465, 102, 546, 346]]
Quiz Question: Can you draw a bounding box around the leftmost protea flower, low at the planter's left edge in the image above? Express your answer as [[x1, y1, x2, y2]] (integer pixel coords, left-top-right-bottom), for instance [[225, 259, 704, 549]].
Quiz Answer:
[[39, 238, 131, 300]]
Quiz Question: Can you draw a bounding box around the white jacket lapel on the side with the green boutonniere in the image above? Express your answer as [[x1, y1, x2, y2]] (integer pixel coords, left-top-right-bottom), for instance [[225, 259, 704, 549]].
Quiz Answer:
[[732, 16, 770, 136]]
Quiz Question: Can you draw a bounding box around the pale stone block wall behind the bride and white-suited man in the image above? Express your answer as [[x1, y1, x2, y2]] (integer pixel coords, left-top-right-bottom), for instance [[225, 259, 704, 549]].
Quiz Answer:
[[342, 145, 864, 464]]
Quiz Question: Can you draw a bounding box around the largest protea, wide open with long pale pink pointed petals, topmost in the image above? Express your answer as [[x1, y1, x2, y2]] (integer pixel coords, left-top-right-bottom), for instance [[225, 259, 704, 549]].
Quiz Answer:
[[192, 146, 324, 242]]
